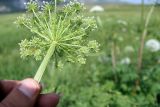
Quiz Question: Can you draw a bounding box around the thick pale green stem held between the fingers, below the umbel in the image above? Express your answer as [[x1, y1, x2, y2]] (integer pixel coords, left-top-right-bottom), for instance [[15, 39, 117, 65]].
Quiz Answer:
[[34, 42, 56, 82]]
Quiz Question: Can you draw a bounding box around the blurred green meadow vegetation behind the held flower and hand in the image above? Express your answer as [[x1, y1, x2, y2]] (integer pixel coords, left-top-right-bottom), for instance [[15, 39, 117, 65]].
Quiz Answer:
[[0, 0, 160, 107]]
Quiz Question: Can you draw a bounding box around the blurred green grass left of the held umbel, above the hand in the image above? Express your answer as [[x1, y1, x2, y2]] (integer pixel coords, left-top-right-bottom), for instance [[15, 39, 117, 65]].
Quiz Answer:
[[0, 14, 38, 79]]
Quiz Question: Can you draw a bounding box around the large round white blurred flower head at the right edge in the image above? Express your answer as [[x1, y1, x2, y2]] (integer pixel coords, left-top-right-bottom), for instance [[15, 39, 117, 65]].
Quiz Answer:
[[145, 39, 160, 52]]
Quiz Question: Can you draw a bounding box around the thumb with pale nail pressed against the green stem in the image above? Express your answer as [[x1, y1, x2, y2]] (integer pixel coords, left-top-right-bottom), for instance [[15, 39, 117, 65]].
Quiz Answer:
[[0, 79, 40, 107]]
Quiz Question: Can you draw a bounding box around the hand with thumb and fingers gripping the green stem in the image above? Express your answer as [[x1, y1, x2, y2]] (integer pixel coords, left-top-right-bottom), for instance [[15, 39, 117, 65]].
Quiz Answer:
[[0, 79, 59, 107]]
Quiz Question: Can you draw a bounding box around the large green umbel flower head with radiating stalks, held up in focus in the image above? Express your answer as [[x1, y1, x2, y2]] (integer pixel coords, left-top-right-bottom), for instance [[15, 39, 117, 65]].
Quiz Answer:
[[16, 1, 99, 64]]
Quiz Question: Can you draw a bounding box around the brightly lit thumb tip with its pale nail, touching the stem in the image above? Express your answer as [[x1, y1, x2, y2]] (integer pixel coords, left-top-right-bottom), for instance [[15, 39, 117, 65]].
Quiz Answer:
[[18, 79, 39, 98]]
